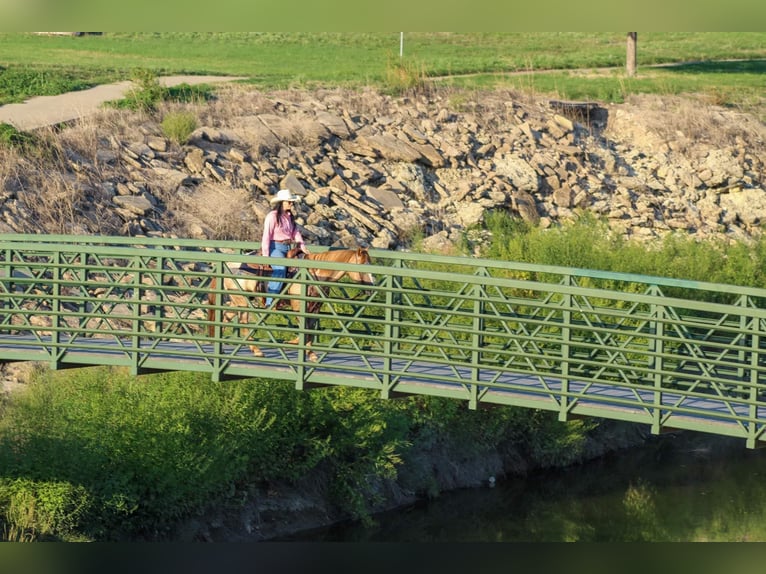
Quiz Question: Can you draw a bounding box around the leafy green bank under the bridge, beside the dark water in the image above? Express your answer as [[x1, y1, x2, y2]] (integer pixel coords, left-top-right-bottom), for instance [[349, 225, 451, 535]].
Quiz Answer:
[[0, 362, 587, 541]]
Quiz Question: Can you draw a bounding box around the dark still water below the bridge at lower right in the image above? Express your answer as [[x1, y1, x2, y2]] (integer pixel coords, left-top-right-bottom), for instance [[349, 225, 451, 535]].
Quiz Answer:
[[280, 434, 766, 542]]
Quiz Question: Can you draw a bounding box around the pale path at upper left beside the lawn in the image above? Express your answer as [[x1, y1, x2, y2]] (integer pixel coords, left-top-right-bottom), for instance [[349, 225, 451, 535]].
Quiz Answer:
[[0, 76, 244, 131]]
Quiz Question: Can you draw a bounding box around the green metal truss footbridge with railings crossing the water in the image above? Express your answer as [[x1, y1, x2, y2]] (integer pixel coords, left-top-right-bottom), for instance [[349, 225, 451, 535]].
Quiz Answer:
[[0, 235, 766, 448]]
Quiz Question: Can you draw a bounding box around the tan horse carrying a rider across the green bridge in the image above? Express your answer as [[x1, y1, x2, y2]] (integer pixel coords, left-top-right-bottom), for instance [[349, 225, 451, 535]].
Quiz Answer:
[[207, 248, 375, 362]]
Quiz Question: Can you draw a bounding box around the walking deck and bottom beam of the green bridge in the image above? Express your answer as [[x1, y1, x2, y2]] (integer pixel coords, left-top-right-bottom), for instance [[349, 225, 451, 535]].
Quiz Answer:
[[0, 335, 766, 441]]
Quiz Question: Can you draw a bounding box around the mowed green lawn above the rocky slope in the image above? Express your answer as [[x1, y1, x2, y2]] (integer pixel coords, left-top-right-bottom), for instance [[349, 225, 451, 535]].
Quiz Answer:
[[0, 32, 766, 113]]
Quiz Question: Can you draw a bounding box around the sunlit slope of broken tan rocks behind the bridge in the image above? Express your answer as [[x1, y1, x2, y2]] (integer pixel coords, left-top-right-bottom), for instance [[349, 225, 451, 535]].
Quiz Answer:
[[0, 88, 766, 253]]
